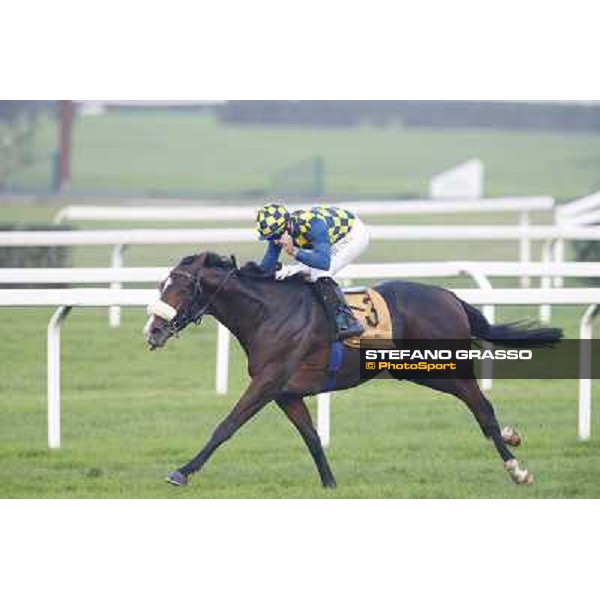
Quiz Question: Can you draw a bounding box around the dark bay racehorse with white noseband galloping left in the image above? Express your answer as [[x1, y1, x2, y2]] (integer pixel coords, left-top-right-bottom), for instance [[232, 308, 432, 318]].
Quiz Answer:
[[145, 252, 562, 487]]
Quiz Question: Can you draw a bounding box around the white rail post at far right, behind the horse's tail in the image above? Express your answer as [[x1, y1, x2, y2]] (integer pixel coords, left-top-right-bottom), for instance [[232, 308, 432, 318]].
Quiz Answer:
[[577, 304, 600, 442]]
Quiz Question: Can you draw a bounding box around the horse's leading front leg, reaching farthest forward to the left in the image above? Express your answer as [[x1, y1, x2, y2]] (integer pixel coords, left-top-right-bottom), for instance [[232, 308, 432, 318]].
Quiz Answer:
[[166, 373, 278, 485]]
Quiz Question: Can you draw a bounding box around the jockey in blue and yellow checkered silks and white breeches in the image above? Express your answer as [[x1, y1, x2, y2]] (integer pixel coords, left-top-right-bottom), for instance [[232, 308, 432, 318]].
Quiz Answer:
[[256, 203, 369, 340]]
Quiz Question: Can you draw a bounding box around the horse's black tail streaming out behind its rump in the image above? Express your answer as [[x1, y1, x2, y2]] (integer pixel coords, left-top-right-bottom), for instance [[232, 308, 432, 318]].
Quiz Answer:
[[459, 298, 563, 348]]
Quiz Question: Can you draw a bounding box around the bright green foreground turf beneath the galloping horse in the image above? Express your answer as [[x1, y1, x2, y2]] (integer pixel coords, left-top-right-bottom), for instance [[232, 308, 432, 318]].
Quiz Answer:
[[0, 309, 600, 498]]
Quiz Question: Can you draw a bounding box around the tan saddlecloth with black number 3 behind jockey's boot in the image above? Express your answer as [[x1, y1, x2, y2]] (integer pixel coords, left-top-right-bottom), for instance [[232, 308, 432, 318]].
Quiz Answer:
[[343, 287, 394, 348]]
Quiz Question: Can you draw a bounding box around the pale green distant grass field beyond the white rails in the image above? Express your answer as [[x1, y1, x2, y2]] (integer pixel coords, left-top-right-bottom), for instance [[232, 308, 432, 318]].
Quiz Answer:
[[11, 110, 600, 199]]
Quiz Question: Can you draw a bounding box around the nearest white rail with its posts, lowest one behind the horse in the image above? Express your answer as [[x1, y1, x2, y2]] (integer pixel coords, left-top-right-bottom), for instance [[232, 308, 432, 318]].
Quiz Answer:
[[0, 276, 600, 448]]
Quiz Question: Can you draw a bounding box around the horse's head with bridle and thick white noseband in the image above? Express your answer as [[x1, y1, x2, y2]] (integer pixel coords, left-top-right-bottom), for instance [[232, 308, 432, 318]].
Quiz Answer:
[[144, 253, 235, 350]]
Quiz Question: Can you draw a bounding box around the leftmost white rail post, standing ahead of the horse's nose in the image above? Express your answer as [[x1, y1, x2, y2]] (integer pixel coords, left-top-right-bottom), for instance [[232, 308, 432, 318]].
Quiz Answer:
[[46, 306, 71, 448]]
